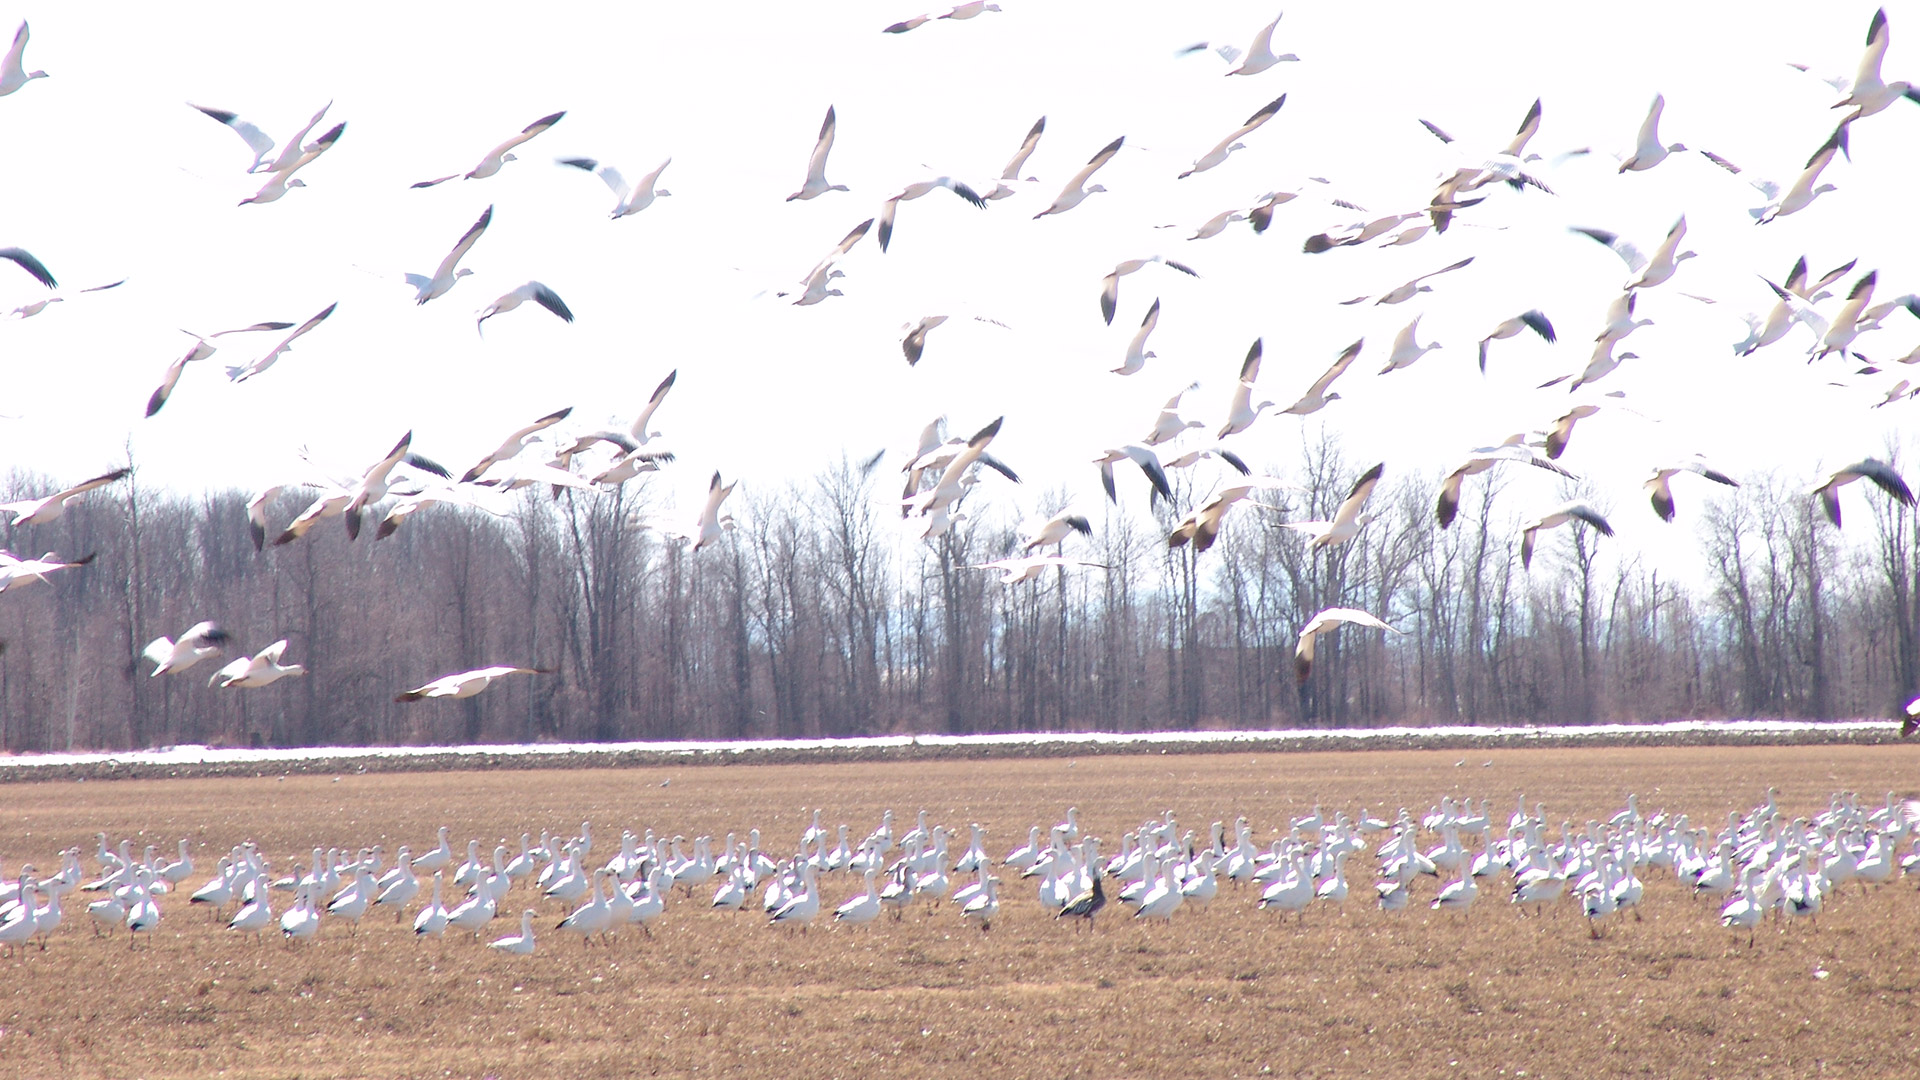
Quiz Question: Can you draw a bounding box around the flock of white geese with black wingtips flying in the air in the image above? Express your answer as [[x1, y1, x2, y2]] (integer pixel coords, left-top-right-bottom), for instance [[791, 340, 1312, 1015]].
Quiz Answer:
[[11, 2, 1920, 715]]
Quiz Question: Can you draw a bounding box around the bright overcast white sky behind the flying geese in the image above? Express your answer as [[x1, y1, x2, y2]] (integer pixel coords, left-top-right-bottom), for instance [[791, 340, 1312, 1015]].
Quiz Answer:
[[0, 0, 1920, 573]]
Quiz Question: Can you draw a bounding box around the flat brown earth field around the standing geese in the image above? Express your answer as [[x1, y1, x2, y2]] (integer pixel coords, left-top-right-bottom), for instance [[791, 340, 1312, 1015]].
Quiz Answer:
[[0, 746, 1920, 1080]]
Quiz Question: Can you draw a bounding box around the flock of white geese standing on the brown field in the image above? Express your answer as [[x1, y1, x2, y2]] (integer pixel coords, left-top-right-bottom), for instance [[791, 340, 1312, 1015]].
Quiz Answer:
[[0, 788, 1920, 955]]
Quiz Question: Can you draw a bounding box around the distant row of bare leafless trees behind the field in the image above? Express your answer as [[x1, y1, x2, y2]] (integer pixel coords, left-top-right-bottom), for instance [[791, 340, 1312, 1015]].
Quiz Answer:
[[0, 438, 1920, 751]]
